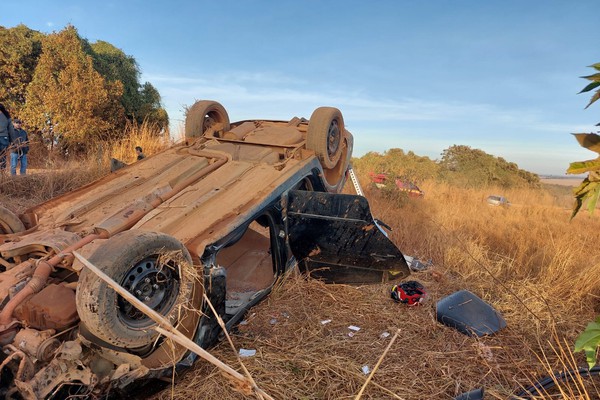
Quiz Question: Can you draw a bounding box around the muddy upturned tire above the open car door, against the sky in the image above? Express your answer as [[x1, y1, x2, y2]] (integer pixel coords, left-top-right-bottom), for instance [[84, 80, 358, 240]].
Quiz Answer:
[[306, 107, 344, 169]]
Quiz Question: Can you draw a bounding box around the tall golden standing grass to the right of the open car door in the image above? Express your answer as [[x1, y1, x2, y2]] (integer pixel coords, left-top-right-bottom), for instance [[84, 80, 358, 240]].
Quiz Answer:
[[358, 176, 600, 399]]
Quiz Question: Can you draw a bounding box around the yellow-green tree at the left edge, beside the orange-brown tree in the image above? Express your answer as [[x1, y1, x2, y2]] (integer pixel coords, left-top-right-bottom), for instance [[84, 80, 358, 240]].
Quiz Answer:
[[0, 25, 43, 115]]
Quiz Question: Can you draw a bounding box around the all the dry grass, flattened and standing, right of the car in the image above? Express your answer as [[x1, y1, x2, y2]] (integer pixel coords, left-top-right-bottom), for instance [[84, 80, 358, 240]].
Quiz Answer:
[[151, 173, 600, 399]]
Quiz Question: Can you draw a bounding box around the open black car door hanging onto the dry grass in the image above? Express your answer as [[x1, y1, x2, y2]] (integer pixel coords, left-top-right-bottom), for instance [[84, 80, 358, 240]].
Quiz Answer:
[[287, 190, 410, 283]]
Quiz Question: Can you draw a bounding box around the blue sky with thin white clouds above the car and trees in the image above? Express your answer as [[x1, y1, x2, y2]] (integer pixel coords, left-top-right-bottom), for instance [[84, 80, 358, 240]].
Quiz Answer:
[[0, 0, 600, 175]]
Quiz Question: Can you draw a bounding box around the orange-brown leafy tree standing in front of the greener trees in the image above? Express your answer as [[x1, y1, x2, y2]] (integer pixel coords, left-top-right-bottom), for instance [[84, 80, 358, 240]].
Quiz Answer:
[[24, 26, 125, 147]]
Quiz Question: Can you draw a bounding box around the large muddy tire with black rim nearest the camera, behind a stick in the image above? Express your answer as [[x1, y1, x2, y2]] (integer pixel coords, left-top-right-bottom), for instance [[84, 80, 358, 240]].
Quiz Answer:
[[76, 230, 194, 349]]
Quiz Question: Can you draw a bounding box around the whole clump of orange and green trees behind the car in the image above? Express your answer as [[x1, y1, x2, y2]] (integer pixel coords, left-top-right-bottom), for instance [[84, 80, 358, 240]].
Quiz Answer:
[[0, 25, 169, 155]]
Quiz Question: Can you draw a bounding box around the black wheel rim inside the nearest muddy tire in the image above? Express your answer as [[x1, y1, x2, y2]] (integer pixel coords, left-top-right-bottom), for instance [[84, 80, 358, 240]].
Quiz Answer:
[[117, 257, 180, 329]]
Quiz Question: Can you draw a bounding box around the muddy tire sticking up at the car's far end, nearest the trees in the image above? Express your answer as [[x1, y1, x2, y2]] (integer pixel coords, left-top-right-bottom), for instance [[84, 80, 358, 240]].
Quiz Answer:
[[185, 100, 230, 138]]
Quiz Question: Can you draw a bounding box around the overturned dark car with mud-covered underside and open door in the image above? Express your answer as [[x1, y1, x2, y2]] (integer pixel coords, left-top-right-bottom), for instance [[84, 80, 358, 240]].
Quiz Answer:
[[0, 101, 409, 399]]
